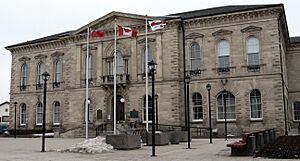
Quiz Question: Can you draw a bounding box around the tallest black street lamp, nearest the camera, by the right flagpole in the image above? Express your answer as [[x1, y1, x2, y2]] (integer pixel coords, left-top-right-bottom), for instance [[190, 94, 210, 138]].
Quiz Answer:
[[148, 60, 157, 157]]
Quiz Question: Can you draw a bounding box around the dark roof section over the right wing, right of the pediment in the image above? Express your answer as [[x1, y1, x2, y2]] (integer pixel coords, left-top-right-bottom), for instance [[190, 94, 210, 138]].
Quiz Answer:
[[168, 4, 283, 19]]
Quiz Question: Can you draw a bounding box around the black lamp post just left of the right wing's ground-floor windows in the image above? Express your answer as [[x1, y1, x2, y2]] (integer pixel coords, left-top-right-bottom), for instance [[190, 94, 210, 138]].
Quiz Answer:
[[185, 75, 191, 149]]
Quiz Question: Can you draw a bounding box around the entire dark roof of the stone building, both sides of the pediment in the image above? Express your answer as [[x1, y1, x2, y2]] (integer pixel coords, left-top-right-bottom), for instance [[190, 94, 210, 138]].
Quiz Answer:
[[5, 4, 283, 49]]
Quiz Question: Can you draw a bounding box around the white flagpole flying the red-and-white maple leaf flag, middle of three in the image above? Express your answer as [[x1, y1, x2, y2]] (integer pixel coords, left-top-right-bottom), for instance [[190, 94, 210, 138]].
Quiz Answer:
[[114, 19, 117, 135]]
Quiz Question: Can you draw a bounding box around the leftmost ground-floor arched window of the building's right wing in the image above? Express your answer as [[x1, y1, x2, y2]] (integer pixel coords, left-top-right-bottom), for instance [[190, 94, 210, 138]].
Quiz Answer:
[[192, 93, 203, 121]]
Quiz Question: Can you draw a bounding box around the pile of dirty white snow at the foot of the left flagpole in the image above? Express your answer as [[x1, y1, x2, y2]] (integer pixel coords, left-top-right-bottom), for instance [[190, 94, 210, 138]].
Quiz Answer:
[[57, 136, 113, 154]]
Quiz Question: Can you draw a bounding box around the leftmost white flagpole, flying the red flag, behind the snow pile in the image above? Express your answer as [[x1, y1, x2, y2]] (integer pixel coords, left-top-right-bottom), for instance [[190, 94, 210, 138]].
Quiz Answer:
[[85, 26, 90, 139]]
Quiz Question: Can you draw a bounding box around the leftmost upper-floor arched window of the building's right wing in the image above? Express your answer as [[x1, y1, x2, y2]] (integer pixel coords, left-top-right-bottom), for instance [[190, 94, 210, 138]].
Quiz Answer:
[[190, 42, 201, 71]]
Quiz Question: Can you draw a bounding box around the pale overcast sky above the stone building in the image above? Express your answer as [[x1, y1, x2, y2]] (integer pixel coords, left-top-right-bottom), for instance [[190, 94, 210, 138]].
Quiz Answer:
[[0, 0, 300, 103]]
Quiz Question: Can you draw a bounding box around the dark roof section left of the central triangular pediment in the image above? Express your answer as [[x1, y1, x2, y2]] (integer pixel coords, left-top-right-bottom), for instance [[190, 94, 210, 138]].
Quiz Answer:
[[5, 31, 73, 49]]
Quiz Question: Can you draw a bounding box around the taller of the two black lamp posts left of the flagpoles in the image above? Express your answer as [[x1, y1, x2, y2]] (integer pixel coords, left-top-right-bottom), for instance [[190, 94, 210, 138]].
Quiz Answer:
[[42, 72, 50, 152]]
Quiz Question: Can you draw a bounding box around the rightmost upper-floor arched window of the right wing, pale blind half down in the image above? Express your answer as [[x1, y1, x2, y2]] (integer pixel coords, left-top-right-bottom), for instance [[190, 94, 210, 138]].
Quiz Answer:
[[247, 36, 259, 66]]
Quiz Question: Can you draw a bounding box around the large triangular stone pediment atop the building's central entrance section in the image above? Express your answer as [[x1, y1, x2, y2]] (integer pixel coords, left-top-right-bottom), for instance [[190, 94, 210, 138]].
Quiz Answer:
[[74, 11, 145, 34]]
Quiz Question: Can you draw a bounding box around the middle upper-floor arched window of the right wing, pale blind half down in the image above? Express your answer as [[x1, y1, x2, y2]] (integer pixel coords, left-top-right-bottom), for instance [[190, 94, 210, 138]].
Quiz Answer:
[[218, 40, 230, 71]]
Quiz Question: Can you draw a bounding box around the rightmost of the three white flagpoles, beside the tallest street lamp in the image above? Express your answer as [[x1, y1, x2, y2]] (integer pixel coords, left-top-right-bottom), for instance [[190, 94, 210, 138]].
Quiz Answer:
[[144, 15, 149, 131]]
